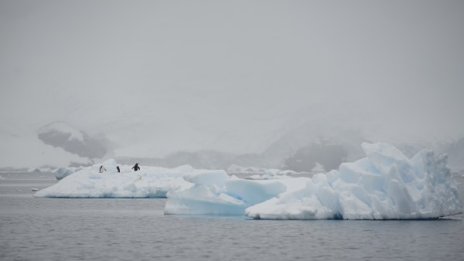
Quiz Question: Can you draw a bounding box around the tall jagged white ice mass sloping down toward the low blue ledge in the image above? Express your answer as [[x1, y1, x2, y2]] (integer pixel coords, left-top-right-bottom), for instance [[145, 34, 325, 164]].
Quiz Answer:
[[245, 143, 461, 219]]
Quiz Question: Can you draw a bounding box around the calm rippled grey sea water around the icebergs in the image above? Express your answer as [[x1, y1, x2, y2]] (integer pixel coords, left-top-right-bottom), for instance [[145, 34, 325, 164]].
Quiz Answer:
[[0, 173, 464, 261]]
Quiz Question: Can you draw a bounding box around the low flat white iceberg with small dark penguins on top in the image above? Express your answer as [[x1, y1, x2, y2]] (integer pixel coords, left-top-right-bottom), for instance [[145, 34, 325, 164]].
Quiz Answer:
[[34, 159, 215, 198]]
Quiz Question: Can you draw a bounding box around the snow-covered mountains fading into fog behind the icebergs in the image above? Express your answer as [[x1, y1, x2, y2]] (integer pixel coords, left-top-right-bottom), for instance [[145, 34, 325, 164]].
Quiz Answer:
[[0, 118, 464, 173]]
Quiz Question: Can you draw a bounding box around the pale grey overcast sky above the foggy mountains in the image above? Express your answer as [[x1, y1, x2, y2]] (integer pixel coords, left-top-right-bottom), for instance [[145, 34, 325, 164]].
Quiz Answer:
[[0, 0, 464, 156]]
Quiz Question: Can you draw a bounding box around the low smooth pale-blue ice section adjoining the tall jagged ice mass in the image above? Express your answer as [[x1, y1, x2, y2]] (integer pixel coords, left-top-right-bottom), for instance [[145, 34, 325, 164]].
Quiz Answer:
[[165, 173, 302, 215]]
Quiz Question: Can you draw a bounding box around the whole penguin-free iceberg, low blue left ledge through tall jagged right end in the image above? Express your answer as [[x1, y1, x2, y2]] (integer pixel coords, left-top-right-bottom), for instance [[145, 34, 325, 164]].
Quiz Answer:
[[165, 143, 462, 219]]
